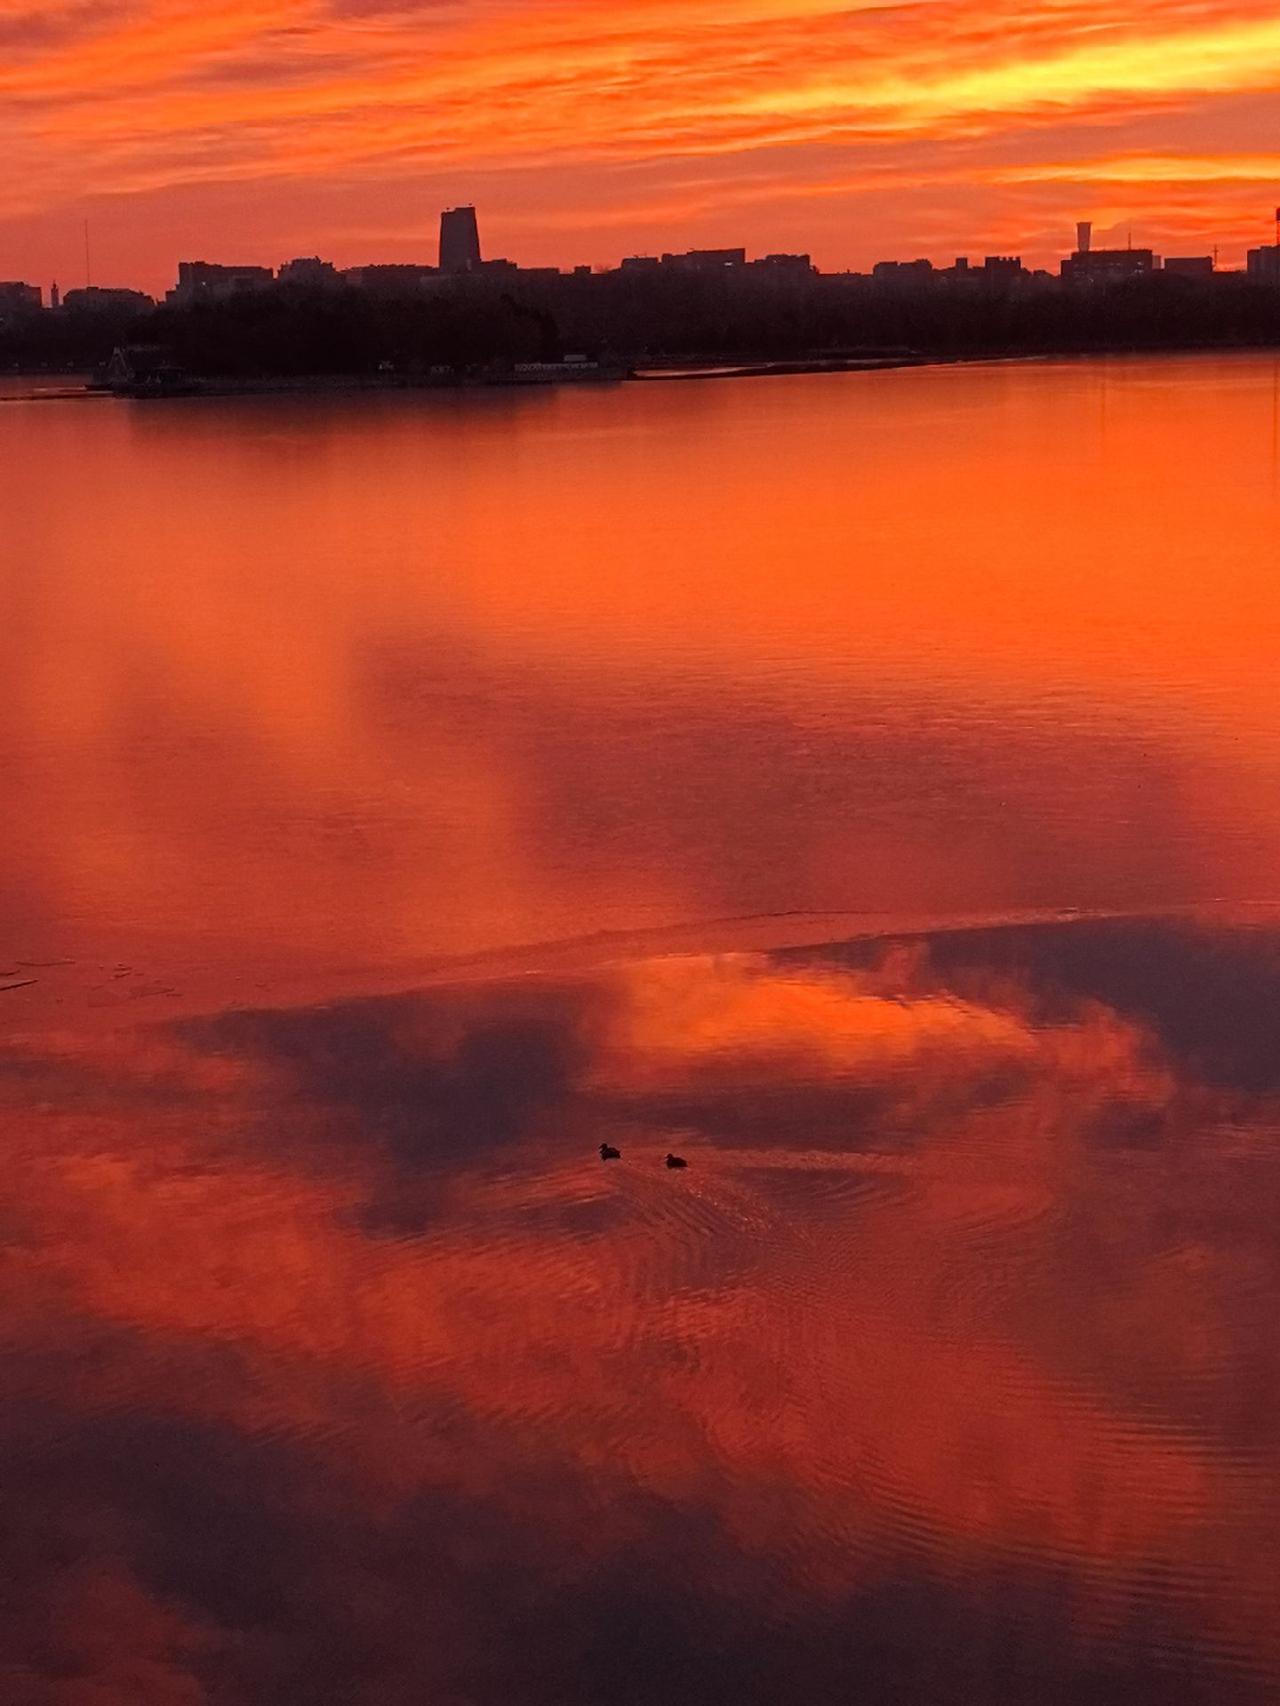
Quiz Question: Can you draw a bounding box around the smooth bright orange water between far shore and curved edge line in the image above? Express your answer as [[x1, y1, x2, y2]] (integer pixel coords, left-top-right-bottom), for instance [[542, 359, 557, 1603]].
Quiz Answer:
[[0, 357, 1280, 1009]]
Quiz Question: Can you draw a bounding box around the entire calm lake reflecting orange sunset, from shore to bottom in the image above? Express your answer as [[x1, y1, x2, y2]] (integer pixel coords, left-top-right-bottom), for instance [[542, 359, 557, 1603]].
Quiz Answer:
[[0, 357, 1280, 1706]]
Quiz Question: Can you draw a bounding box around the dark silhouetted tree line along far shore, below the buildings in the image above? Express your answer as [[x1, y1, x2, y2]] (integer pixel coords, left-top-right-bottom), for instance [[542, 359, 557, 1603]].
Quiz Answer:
[[0, 270, 1280, 377]]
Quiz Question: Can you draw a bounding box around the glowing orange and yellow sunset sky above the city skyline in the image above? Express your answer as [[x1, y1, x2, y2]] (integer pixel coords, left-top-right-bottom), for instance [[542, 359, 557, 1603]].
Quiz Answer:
[[0, 0, 1280, 290]]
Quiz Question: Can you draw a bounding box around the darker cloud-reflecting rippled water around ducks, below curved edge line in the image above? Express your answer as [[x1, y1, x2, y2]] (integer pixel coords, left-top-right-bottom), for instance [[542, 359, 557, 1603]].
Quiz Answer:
[[0, 925, 1280, 1706]]
